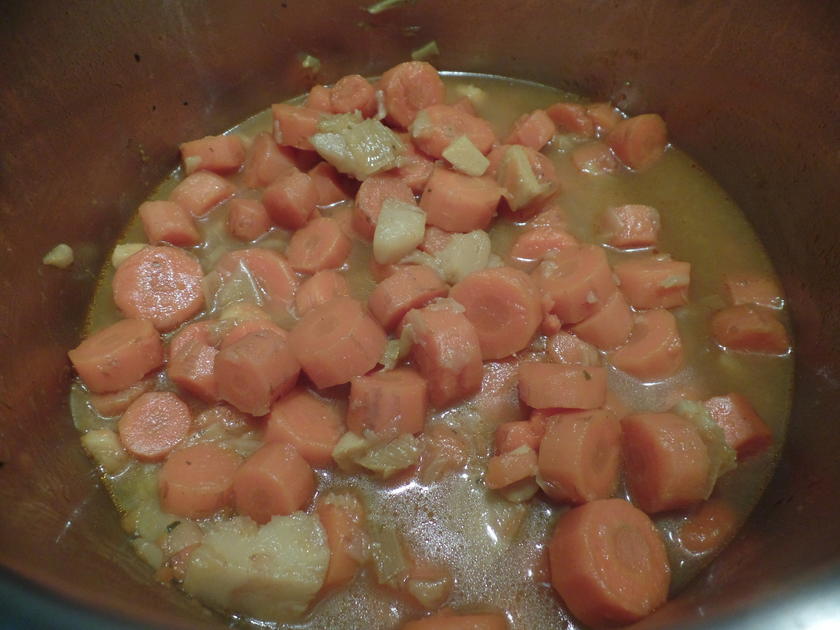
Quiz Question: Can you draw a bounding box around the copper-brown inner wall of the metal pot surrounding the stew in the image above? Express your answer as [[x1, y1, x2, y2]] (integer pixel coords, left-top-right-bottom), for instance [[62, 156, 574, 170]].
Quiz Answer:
[[0, 0, 840, 629]]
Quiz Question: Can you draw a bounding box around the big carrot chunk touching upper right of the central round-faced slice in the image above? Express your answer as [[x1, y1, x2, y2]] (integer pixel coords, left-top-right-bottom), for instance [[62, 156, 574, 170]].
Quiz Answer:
[[533, 245, 617, 324]]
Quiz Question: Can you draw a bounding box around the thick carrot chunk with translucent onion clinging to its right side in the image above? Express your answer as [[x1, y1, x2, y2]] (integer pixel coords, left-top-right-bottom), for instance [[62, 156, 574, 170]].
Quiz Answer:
[[621, 413, 710, 514]]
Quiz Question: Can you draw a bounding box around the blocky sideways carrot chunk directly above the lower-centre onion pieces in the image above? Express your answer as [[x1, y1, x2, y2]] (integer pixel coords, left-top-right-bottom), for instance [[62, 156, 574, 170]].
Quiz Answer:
[[347, 368, 429, 437]]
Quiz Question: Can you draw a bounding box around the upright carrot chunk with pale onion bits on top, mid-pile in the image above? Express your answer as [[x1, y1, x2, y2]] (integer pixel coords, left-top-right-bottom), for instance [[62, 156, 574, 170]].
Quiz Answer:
[[403, 304, 483, 408]]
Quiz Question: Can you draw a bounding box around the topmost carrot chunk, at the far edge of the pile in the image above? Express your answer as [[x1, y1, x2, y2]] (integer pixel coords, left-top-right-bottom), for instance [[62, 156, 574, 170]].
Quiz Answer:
[[379, 61, 446, 129]]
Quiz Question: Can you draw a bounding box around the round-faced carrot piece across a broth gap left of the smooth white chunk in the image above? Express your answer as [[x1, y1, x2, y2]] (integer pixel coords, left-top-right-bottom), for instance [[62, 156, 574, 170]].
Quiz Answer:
[[286, 217, 352, 273]]
